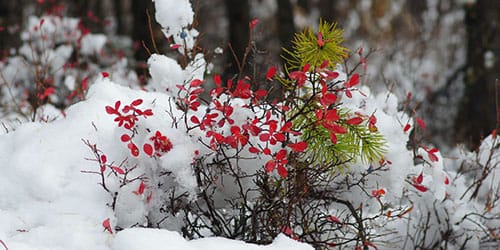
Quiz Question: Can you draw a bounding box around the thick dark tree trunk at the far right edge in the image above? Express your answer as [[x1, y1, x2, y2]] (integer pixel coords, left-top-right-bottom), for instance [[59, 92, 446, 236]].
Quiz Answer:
[[455, 0, 500, 148]]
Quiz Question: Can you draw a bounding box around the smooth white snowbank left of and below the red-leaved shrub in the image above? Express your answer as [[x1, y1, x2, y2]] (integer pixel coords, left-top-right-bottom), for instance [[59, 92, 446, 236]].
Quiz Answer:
[[0, 78, 312, 250]]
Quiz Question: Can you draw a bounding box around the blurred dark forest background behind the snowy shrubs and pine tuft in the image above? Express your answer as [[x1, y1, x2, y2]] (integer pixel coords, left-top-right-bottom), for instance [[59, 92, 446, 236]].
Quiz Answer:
[[0, 0, 500, 149]]
